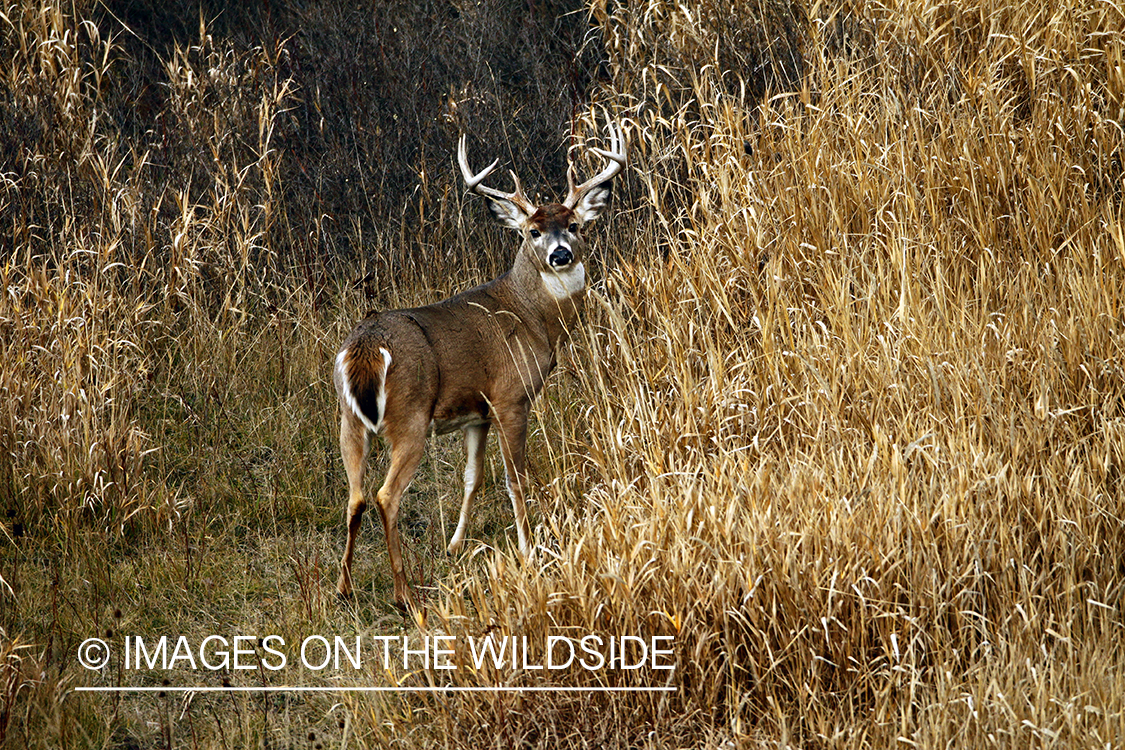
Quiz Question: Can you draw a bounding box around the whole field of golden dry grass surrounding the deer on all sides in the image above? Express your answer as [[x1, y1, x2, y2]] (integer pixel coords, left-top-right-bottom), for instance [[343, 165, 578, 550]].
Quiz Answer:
[[0, 0, 1125, 750]]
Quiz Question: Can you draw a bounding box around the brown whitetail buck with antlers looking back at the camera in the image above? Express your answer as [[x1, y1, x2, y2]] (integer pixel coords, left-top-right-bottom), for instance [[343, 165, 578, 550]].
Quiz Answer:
[[334, 127, 626, 608]]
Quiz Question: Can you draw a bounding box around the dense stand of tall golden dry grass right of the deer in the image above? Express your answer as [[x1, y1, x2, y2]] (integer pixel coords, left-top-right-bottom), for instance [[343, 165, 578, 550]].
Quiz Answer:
[[414, 3, 1125, 747]]
